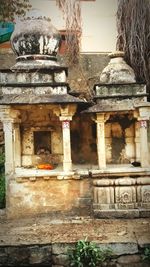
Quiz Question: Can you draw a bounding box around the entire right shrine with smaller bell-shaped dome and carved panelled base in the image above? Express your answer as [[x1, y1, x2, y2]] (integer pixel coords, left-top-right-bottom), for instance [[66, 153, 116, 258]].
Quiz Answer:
[[84, 51, 150, 217]]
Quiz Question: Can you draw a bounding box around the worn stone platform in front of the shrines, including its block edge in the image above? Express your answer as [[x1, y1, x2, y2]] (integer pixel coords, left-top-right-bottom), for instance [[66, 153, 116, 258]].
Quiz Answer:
[[0, 215, 150, 267]]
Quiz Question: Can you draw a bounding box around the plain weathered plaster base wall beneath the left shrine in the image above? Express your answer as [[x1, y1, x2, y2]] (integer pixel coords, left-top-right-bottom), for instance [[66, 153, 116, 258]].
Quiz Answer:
[[7, 177, 91, 218]]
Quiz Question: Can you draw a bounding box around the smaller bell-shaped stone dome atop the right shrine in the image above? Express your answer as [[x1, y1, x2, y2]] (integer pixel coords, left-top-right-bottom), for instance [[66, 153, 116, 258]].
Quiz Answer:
[[100, 51, 136, 84]]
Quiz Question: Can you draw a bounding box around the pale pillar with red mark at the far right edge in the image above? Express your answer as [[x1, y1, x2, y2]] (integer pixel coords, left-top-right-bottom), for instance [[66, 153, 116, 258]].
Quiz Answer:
[[138, 117, 150, 168]]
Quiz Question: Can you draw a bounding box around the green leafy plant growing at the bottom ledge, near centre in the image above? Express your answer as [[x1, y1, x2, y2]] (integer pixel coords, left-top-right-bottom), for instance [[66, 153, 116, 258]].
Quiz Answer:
[[68, 240, 112, 267]]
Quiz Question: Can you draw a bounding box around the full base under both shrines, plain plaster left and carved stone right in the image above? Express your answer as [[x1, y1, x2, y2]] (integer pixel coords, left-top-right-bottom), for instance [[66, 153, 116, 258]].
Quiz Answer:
[[6, 171, 150, 219]]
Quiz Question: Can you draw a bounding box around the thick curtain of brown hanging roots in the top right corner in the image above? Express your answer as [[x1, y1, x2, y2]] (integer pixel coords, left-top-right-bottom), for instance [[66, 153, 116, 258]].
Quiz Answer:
[[117, 0, 150, 98]]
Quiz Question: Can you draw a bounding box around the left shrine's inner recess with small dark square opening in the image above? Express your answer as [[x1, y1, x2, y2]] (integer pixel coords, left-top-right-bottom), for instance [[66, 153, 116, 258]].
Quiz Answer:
[[21, 106, 63, 167]]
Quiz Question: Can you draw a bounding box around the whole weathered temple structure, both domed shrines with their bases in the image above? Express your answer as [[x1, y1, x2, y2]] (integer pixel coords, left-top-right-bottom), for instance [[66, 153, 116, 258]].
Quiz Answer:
[[0, 12, 150, 218]]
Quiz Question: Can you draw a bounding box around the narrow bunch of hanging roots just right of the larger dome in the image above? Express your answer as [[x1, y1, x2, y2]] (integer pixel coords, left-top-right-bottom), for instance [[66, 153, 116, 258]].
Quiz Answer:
[[56, 0, 82, 65]]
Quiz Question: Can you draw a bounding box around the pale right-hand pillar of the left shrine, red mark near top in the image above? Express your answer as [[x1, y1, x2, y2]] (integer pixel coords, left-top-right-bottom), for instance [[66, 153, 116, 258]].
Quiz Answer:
[[60, 116, 72, 171]]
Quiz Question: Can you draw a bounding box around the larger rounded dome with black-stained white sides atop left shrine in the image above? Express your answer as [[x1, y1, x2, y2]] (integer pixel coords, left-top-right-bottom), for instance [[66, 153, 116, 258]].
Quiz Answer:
[[11, 10, 61, 58]]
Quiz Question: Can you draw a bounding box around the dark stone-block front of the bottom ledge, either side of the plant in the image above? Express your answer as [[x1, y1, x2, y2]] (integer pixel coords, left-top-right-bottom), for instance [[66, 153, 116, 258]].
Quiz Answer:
[[0, 243, 149, 267]]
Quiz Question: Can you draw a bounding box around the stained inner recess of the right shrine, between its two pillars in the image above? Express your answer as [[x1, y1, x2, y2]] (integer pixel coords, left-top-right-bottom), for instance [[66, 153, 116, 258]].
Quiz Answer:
[[105, 112, 139, 164]]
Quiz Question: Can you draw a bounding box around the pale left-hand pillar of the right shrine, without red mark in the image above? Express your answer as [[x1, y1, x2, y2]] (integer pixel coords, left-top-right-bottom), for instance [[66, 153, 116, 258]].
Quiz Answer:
[[96, 113, 106, 169]]
